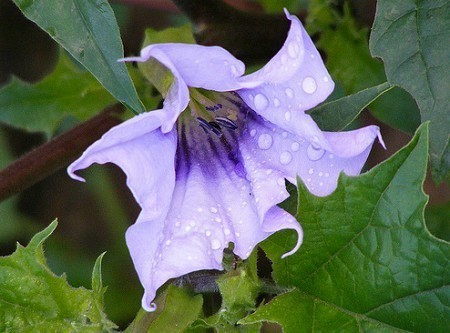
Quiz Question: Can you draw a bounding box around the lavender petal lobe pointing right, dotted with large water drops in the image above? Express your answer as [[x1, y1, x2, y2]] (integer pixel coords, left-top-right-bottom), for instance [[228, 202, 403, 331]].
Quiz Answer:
[[240, 114, 382, 197]]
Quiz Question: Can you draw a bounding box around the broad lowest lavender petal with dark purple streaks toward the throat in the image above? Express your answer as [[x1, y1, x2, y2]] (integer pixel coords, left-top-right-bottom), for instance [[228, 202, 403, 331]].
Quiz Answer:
[[127, 127, 302, 310]]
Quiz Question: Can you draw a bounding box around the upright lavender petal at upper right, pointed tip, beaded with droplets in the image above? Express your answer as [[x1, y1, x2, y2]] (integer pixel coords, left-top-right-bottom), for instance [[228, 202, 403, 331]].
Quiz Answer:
[[238, 10, 334, 135]]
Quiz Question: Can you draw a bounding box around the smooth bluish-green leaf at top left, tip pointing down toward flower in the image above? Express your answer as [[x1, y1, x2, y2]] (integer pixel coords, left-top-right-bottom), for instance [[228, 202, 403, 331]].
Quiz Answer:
[[14, 0, 145, 113]]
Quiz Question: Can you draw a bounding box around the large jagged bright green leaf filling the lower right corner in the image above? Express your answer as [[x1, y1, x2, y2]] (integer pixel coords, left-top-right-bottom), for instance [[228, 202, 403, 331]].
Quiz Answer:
[[263, 124, 450, 332]]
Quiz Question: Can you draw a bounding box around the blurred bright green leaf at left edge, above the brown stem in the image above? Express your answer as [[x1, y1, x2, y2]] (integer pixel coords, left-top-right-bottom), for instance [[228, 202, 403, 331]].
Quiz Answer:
[[0, 53, 114, 136]]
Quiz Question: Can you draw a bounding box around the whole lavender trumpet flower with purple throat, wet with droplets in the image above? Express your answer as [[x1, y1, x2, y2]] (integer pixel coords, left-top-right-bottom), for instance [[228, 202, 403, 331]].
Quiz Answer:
[[68, 13, 381, 311]]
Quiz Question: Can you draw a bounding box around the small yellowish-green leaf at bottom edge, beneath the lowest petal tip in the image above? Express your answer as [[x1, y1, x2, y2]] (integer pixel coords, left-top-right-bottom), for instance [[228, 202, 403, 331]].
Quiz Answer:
[[125, 285, 203, 333]]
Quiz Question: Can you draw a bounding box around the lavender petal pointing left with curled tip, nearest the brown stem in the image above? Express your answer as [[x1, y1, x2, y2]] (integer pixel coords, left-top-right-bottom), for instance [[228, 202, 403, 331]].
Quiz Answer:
[[67, 110, 176, 218]]
